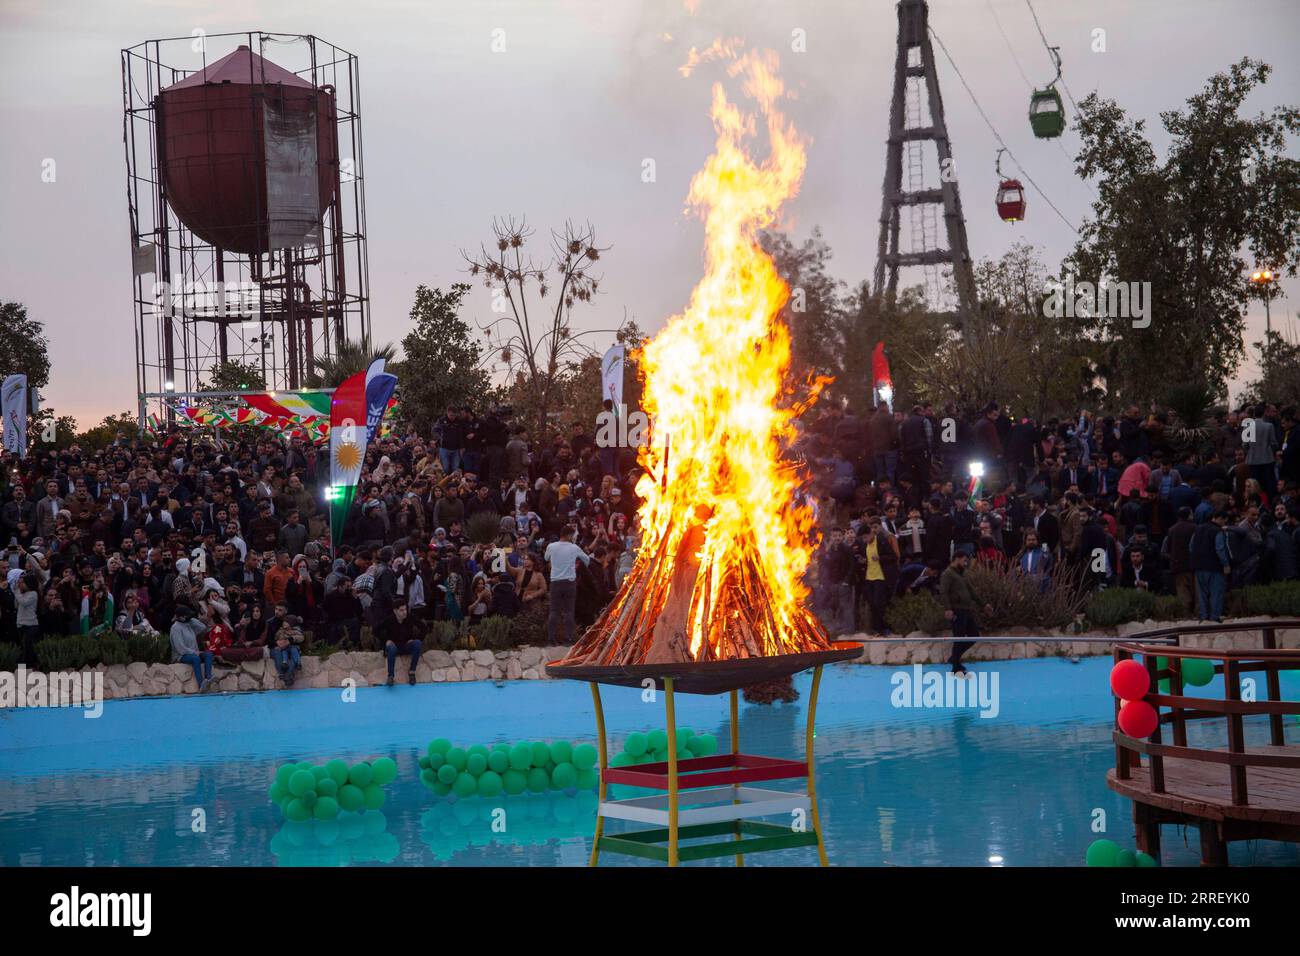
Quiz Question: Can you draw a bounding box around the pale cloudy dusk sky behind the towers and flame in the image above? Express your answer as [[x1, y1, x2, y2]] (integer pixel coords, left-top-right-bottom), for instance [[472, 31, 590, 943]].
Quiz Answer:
[[0, 0, 1300, 425]]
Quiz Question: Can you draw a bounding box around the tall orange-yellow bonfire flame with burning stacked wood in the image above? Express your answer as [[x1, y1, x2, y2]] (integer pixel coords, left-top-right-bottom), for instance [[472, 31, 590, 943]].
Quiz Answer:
[[569, 44, 831, 663]]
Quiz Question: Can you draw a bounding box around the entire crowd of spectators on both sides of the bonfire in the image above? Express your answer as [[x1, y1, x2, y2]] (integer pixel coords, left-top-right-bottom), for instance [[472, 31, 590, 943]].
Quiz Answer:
[[0, 390, 1300, 687]]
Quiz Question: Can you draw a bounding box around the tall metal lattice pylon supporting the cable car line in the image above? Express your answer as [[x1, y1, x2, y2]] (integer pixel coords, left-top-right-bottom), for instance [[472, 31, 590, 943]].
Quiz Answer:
[[875, 0, 975, 319]]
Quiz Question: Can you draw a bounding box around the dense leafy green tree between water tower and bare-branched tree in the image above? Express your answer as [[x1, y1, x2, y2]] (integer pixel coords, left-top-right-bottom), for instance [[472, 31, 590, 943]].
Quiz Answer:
[[394, 282, 497, 433]]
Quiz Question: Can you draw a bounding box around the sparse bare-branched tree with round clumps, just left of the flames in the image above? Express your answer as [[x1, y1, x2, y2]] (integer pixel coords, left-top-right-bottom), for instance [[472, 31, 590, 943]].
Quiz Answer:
[[462, 219, 608, 433]]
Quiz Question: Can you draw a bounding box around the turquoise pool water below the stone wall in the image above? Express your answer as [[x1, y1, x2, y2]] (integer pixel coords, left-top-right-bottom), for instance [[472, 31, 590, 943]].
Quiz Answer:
[[0, 658, 1300, 866]]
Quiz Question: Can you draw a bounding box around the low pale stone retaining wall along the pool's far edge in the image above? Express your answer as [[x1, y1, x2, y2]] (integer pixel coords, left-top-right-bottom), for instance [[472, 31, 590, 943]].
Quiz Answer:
[[5, 619, 1300, 700]]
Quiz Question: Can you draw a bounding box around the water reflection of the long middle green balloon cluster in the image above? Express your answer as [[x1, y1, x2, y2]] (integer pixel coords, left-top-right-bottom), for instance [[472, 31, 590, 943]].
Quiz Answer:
[[420, 790, 597, 860]]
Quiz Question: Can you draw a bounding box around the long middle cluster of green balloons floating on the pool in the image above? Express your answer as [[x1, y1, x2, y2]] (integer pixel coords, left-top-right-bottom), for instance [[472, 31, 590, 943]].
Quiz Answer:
[[420, 737, 601, 799]]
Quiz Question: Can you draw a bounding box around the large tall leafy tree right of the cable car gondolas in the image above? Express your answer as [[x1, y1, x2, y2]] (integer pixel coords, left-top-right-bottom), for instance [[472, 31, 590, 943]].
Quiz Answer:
[[1066, 59, 1300, 402]]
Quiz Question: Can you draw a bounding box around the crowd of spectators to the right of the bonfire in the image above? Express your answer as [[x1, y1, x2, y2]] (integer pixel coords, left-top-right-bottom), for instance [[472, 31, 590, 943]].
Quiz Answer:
[[805, 403, 1300, 672]]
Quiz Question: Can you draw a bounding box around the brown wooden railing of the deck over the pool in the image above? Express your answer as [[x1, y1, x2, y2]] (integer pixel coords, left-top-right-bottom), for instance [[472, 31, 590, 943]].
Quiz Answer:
[[1114, 619, 1300, 806]]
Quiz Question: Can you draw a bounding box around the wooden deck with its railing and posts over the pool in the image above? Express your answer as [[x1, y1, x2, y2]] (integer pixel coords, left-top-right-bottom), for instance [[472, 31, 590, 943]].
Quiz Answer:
[[1106, 620, 1300, 866]]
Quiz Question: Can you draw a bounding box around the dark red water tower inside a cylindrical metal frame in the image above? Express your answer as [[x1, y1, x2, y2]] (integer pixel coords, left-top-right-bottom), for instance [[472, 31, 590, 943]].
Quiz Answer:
[[122, 33, 371, 418]]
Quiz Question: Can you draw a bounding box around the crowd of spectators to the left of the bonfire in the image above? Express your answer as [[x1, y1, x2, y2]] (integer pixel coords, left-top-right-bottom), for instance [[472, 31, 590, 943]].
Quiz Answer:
[[0, 410, 636, 687]]
